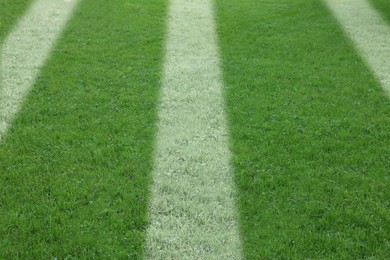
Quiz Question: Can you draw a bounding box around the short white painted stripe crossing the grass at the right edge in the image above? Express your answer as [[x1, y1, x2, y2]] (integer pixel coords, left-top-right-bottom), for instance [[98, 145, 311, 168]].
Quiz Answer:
[[324, 0, 390, 94]]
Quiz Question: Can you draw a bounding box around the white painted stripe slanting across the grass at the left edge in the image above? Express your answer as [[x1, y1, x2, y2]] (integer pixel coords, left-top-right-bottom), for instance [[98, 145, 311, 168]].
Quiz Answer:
[[0, 0, 78, 142]]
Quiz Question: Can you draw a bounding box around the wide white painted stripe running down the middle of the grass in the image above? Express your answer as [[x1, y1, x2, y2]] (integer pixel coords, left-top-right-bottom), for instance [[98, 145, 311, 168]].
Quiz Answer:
[[146, 0, 241, 259]]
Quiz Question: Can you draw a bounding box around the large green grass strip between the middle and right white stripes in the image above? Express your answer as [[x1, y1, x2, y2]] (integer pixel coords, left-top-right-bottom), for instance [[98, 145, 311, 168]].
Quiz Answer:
[[216, 0, 390, 259]]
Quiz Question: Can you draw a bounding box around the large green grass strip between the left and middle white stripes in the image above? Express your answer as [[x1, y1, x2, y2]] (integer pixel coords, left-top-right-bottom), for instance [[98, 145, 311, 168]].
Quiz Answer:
[[0, 0, 166, 259]]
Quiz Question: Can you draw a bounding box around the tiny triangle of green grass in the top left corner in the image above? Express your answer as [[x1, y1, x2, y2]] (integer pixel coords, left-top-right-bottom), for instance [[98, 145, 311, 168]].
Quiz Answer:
[[0, 0, 32, 44]]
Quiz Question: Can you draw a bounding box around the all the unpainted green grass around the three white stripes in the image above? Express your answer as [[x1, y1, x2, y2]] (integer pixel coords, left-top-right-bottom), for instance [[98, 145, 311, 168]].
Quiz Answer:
[[0, 0, 390, 259]]
